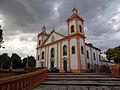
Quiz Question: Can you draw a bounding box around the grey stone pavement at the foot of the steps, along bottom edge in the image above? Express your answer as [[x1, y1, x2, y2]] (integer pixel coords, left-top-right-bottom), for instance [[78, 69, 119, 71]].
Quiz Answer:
[[33, 85, 120, 90]]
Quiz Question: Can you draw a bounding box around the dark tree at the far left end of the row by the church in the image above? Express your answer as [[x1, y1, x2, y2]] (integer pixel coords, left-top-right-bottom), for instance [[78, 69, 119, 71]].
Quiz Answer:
[[0, 53, 10, 69]]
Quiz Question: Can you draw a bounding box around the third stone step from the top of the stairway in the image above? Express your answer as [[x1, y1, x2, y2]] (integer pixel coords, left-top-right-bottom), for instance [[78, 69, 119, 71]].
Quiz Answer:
[[46, 78, 120, 81]]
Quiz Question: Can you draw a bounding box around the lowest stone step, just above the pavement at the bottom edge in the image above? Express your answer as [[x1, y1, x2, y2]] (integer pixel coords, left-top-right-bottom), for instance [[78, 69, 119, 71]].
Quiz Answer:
[[43, 81, 120, 86]]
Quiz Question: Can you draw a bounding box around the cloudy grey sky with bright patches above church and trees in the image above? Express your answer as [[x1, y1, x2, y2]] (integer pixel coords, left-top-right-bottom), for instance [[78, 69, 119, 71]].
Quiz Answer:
[[0, 0, 120, 57]]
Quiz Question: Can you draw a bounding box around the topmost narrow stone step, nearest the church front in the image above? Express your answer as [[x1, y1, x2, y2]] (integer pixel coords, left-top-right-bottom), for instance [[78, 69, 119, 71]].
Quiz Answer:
[[48, 73, 103, 75]]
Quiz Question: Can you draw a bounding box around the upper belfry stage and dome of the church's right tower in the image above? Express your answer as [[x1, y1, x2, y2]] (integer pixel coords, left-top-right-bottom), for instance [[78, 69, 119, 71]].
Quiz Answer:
[[67, 8, 84, 36]]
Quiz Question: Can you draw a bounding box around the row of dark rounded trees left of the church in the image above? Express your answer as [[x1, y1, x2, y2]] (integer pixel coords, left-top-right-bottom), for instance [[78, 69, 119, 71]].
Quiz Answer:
[[0, 53, 36, 69]]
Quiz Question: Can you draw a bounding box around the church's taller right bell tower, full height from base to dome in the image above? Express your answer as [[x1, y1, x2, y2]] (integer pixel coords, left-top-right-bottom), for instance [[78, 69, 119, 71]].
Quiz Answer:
[[67, 8, 87, 72]]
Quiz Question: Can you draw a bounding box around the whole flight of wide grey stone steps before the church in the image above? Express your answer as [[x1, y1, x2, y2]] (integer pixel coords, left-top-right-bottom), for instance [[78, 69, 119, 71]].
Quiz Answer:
[[33, 73, 120, 90]]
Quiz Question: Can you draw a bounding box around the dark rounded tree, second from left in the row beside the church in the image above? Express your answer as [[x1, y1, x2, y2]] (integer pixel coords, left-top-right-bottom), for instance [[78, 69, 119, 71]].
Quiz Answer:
[[10, 53, 22, 68]]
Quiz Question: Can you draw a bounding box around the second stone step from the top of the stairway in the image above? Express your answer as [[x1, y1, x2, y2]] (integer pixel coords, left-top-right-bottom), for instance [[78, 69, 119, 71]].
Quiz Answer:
[[47, 75, 110, 78]]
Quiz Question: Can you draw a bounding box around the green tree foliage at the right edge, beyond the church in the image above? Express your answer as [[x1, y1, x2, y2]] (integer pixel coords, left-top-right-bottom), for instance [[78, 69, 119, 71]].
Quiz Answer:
[[106, 46, 120, 63]]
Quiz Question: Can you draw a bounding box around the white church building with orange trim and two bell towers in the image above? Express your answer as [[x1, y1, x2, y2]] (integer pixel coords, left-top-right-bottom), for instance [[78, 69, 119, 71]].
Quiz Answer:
[[36, 8, 101, 72]]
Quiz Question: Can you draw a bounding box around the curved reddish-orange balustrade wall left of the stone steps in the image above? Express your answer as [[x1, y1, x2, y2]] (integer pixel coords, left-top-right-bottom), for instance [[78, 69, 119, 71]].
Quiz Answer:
[[0, 68, 47, 90]]
